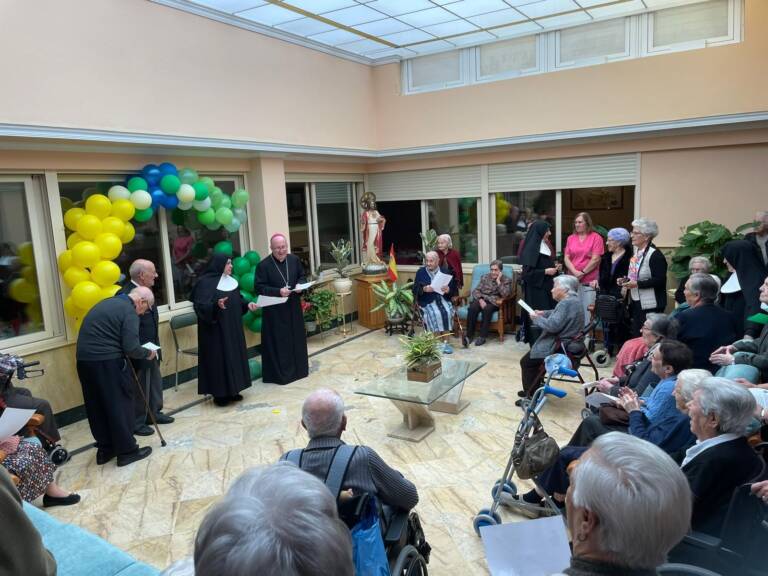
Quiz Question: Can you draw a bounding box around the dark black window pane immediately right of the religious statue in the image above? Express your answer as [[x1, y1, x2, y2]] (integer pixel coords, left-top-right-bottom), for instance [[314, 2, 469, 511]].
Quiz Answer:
[[376, 200, 422, 266]]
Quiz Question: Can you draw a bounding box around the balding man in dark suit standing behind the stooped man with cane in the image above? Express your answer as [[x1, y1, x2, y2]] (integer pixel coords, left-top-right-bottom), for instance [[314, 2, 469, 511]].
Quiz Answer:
[[123, 260, 173, 436]]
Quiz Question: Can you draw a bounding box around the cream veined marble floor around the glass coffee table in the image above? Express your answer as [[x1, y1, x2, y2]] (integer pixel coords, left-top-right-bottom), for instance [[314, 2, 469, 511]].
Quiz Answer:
[[49, 326, 612, 576]]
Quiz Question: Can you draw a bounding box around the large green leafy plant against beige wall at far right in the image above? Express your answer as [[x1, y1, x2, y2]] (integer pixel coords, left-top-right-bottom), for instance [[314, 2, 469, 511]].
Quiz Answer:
[[670, 220, 755, 278]]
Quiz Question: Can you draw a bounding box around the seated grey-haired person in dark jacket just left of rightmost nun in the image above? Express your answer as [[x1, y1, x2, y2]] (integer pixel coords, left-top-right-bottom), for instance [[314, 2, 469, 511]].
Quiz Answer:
[[675, 274, 740, 374]]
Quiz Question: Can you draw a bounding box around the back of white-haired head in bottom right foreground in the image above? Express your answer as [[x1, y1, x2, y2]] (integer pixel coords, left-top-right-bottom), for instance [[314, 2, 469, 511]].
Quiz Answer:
[[552, 432, 691, 576]]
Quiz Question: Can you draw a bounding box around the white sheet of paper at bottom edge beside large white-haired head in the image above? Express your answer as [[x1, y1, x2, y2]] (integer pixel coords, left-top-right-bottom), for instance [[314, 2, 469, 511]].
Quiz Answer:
[[480, 516, 571, 576]]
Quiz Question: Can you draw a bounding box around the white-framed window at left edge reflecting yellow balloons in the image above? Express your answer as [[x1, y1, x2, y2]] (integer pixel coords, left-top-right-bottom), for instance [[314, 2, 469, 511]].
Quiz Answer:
[[0, 176, 60, 349]]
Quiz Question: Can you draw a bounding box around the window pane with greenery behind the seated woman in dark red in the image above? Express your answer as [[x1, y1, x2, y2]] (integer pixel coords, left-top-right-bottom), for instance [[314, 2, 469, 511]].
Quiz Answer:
[[426, 198, 478, 262]]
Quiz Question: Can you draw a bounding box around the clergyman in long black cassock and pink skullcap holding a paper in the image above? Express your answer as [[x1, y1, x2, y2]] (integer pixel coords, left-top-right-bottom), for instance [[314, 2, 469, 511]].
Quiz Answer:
[[254, 234, 309, 384]]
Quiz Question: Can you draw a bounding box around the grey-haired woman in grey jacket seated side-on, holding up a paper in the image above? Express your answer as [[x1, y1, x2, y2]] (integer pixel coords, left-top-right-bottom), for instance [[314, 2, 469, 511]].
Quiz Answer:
[[517, 276, 584, 405]]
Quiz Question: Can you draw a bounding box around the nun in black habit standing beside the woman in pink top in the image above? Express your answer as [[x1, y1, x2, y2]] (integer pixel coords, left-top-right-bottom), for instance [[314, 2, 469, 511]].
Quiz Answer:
[[520, 220, 558, 344]]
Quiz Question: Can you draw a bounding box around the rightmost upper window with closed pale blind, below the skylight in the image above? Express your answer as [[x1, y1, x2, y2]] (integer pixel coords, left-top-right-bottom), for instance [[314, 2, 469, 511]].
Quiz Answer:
[[649, 0, 730, 48]]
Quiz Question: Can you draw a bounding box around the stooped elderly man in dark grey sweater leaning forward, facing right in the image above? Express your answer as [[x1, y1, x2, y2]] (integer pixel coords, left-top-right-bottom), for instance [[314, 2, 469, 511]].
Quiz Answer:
[[77, 286, 159, 466]]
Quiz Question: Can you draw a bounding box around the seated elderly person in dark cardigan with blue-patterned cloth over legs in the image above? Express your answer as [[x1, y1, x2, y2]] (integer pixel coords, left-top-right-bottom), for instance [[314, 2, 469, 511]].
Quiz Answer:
[[413, 251, 458, 354]]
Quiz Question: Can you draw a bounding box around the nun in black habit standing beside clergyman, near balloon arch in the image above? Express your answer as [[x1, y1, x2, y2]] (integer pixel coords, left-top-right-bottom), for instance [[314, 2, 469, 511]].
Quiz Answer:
[[191, 254, 251, 406]]
